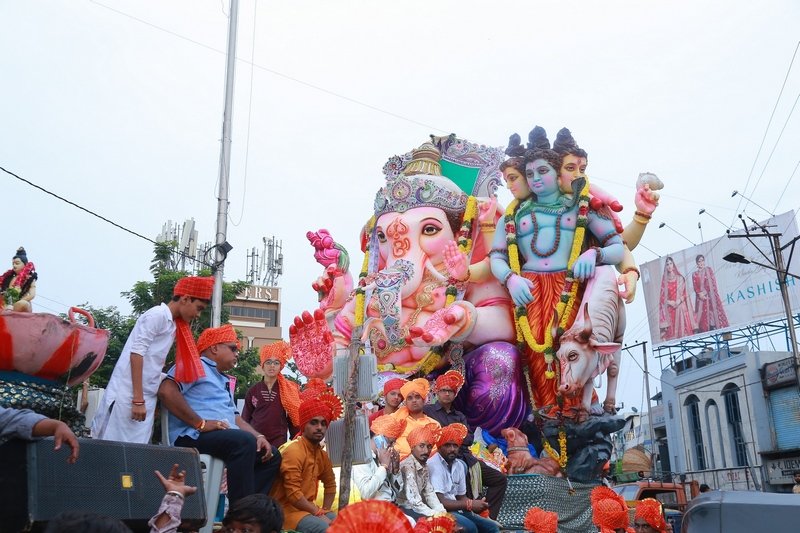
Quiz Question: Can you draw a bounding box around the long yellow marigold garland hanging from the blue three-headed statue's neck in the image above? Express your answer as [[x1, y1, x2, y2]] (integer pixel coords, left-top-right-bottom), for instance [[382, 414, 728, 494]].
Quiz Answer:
[[504, 180, 589, 379]]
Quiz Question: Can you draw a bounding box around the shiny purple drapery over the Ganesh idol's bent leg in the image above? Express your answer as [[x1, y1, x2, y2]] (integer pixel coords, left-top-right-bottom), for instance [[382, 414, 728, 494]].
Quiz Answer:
[[456, 342, 528, 436]]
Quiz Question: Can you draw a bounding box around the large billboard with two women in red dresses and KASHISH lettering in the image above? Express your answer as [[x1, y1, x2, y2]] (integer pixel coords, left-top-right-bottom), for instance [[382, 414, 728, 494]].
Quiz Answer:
[[640, 212, 800, 346]]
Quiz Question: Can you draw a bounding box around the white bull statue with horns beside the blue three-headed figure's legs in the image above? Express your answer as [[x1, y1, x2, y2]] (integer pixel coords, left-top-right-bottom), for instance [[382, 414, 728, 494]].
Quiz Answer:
[[553, 266, 625, 415]]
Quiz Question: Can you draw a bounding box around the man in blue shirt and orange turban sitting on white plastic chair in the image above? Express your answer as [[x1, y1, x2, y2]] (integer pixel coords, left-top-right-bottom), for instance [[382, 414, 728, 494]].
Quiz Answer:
[[158, 324, 281, 503]]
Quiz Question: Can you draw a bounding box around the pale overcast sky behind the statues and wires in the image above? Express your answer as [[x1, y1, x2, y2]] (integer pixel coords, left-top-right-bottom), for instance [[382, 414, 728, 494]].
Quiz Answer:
[[0, 0, 800, 407]]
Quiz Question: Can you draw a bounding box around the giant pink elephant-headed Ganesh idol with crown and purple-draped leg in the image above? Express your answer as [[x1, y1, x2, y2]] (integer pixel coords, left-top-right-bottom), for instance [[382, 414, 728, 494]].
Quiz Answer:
[[290, 137, 525, 432]]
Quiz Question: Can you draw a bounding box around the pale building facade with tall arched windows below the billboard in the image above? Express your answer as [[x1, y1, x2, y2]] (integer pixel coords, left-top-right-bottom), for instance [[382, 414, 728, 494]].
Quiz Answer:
[[661, 348, 800, 492]]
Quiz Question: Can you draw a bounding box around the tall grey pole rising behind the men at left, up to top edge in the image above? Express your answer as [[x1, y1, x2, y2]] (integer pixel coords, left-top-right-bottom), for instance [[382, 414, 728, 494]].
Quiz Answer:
[[211, 0, 239, 328]]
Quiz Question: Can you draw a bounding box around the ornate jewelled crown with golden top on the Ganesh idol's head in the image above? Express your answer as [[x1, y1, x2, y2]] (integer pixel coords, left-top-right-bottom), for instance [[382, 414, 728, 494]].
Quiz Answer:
[[375, 143, 468, 217]]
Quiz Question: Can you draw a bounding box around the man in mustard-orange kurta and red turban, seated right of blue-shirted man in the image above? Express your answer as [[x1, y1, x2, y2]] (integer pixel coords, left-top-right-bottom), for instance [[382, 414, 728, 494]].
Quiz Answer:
[[270, 392, 342, 533]]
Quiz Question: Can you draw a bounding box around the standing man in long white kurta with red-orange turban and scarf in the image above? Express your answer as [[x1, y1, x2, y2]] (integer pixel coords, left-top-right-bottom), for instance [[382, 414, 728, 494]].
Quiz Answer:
[[92, 277, 213, 444]]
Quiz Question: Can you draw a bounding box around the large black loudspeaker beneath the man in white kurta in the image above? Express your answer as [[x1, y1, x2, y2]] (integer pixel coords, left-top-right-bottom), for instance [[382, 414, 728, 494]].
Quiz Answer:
[[0, 438, 206, 533]]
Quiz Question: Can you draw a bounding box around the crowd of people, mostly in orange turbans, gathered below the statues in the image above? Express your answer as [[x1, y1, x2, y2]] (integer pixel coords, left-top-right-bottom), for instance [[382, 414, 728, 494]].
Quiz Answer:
[[0, 277, 680, 533]]
